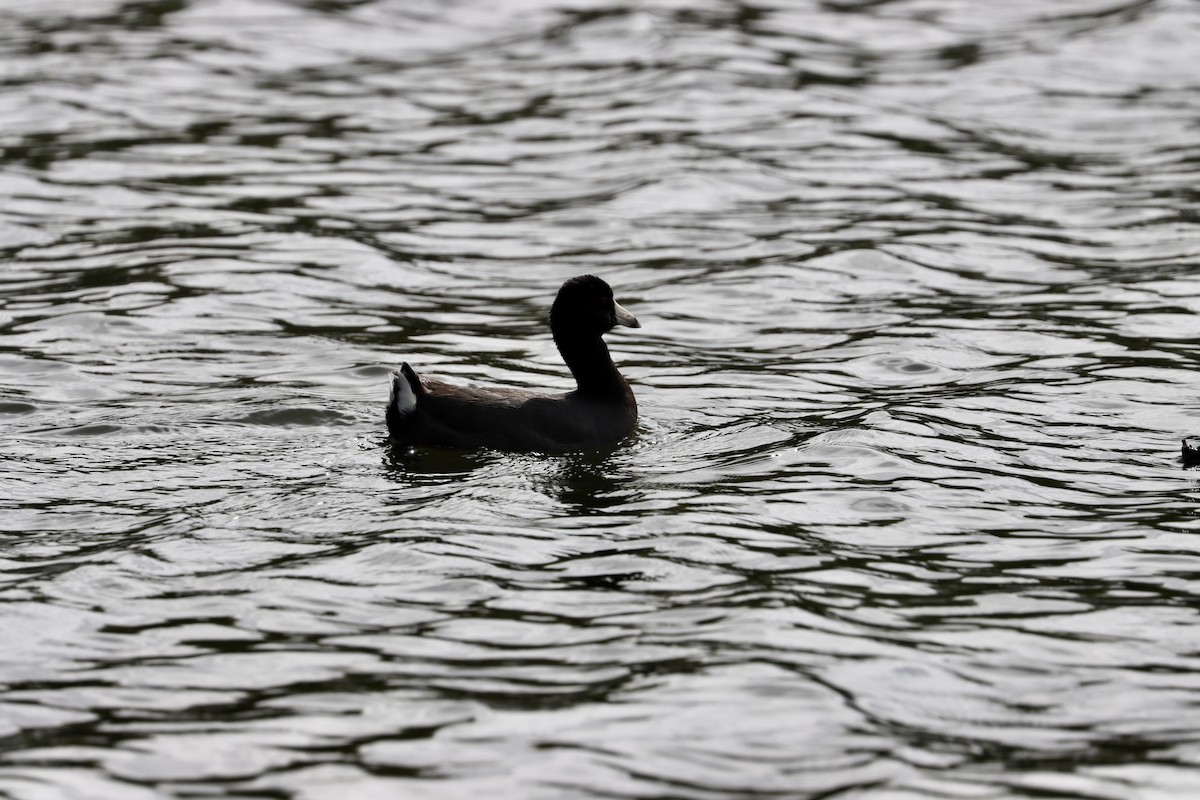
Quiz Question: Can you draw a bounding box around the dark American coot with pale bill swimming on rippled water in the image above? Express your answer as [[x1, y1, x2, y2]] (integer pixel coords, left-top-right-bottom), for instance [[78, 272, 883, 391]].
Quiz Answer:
[[386, 275, 641, 453]]
